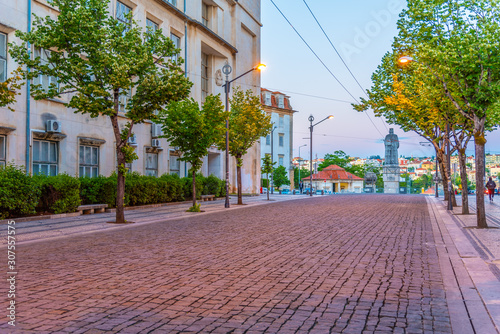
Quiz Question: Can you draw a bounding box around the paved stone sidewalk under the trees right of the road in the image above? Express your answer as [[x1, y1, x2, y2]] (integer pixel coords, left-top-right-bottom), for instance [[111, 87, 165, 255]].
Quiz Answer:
[[427, 197, 500, 333]]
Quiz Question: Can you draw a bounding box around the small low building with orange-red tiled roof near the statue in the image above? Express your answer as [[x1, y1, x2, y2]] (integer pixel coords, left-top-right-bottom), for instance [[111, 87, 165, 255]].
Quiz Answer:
[[302, 165, 364, 194]]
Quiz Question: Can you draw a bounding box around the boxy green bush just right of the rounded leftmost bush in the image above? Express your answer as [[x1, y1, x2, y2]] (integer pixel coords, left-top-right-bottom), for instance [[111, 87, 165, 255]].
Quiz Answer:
[[33, 174, 81, 214]]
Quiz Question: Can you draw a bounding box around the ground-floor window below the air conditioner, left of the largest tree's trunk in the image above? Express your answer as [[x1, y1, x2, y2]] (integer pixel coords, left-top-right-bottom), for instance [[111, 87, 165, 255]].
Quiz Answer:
[[33, 140, 59, 176]]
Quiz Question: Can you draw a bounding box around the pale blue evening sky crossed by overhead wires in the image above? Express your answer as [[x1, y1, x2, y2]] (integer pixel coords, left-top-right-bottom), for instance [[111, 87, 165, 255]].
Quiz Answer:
[[261, 0, 500, 158]]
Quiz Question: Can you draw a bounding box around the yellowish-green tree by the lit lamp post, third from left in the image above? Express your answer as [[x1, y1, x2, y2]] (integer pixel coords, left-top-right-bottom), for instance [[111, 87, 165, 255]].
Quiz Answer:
[[217, 88, 271, 204]]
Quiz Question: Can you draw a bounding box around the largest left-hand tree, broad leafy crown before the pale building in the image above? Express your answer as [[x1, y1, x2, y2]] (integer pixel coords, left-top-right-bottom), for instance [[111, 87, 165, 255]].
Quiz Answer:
[[10, 0, 192, 223]]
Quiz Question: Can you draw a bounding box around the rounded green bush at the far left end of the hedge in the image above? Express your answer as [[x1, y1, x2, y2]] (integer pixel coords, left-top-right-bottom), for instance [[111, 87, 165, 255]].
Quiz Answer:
[[0, 165, 41, 219]]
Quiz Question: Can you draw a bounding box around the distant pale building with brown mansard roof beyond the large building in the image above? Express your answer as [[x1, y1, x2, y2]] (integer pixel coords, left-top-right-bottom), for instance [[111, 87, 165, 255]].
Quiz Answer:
[[260, 88, 297, 189]]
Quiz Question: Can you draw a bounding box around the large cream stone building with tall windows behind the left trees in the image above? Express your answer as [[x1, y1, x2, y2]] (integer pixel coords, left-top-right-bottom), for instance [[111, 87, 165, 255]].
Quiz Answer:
[[0, 0, 262, 193]]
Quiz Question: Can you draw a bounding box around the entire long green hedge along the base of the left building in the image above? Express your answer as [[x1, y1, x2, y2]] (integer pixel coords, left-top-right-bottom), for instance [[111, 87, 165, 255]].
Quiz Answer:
[[0, 165, 226, 219]]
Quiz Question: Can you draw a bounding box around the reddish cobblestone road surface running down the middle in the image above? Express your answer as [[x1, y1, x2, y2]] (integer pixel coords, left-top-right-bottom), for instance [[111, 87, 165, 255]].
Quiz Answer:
[[0, 195, 470, 334]]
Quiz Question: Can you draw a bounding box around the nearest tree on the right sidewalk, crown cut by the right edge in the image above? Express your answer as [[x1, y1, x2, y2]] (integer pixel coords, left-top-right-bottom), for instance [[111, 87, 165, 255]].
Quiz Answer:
[[396, 0, 500, 228]]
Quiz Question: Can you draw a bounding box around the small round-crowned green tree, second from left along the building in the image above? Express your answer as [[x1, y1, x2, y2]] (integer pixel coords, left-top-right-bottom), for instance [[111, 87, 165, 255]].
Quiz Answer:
[[158, 95, 227, 211]]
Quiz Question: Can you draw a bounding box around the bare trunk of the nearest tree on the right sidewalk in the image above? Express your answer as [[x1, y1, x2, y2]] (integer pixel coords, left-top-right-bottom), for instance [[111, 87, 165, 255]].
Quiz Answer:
[[474, 124, 488, 228]]
